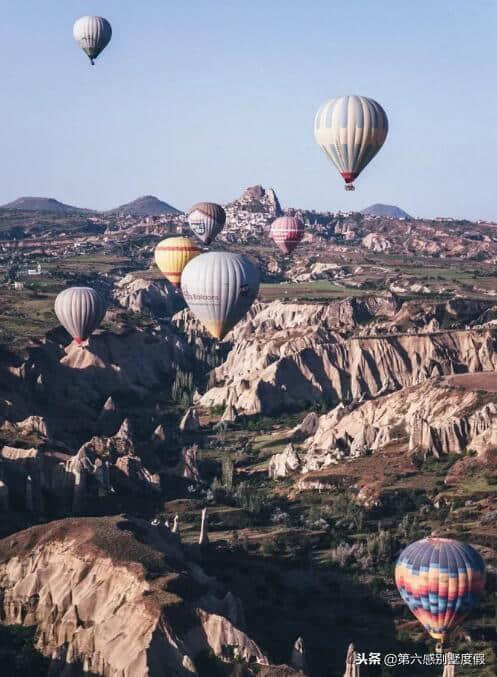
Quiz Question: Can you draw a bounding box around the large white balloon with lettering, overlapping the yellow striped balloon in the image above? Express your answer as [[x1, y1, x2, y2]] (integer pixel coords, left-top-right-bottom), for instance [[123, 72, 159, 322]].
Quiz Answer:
[[181, 252, 259, 339]]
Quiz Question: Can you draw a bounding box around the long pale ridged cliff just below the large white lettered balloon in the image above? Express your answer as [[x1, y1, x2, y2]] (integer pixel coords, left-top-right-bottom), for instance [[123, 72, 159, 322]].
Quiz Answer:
[[200, 316, 497, 414]]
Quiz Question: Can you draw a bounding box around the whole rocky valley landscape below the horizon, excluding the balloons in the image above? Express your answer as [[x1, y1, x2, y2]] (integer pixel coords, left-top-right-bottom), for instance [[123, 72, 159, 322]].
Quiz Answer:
[[0, 193, 497, 677]]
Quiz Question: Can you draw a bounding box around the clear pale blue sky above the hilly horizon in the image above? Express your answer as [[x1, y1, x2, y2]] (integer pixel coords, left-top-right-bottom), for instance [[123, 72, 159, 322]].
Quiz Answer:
[[0, 0, 497, 220]]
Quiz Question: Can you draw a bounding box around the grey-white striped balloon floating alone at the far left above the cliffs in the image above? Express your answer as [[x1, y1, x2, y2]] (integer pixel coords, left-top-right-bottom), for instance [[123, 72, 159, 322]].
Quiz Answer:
[[55, 287, 107, 345]]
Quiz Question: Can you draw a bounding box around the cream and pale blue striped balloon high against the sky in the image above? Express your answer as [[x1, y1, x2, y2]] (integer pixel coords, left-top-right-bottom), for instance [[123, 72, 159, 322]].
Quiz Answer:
[[314, 96, 388, 190]]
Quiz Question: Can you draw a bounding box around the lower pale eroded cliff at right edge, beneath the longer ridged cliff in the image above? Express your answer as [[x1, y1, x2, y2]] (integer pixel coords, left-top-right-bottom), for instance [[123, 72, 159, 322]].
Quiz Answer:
[[304, 371, 497, 471]]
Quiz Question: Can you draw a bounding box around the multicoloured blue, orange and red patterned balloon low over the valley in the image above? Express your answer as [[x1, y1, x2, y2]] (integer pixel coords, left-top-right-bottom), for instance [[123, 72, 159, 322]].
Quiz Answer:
[[395, 537, 485, 643]]
